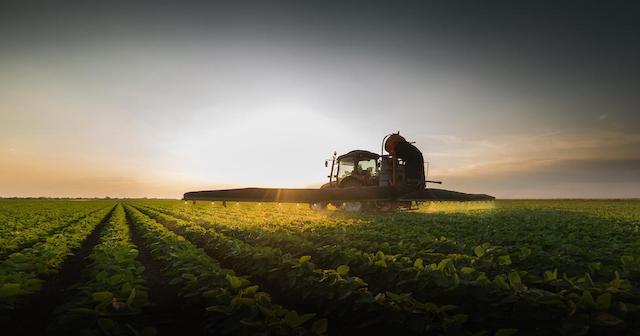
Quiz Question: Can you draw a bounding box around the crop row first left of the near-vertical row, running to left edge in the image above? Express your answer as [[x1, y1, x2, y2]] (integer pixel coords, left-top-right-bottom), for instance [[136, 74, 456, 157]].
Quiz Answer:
[[0, 207, 112, 310]]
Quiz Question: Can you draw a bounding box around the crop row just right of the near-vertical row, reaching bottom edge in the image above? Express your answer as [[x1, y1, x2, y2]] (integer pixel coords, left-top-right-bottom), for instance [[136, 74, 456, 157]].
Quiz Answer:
[[126, 203, 327, 335]]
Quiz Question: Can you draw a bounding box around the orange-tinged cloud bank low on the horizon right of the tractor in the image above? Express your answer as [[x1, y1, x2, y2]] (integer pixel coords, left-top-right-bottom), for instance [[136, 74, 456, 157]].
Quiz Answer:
[[430, 129, 640, 198]]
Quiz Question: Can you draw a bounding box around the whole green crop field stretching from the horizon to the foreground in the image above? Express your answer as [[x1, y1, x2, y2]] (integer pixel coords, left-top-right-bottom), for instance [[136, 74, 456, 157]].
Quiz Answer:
[[0, 200, 640, 336]]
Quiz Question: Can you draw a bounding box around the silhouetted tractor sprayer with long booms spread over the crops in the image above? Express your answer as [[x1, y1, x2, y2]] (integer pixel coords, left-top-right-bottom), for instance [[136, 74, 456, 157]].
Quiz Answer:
[[184, 132, 495, 211]]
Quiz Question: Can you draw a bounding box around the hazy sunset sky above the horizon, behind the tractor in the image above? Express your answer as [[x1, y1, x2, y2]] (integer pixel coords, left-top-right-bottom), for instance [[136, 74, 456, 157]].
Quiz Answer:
[[0, 1, 640, 198]]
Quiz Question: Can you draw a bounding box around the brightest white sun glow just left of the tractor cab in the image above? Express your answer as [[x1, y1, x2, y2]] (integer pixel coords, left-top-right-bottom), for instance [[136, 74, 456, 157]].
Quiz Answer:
[[164, 104, 353, 187]]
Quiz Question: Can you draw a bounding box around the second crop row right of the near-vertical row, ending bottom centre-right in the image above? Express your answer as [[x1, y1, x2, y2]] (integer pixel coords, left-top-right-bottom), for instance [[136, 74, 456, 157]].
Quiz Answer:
[[135, 208, 467, 334]]
